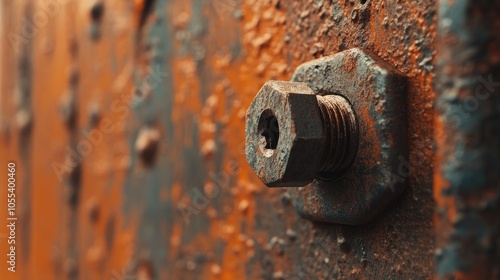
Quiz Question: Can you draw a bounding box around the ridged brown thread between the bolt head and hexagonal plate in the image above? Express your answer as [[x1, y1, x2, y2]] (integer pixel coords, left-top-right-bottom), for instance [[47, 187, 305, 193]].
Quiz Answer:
[[317, 95, 359, 180]]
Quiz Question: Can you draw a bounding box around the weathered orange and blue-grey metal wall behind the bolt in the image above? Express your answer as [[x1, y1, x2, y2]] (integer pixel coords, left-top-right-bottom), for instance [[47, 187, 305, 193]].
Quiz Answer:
[[0, 0, 498, 279]]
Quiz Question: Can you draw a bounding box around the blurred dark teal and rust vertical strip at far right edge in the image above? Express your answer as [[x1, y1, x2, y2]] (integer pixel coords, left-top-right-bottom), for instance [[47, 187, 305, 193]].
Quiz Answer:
[[434, 1, 500, 279]]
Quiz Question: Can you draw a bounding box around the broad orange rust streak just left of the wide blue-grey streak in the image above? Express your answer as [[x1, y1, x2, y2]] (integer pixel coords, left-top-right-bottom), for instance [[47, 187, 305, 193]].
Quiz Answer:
[[74, 1, 138, 279]]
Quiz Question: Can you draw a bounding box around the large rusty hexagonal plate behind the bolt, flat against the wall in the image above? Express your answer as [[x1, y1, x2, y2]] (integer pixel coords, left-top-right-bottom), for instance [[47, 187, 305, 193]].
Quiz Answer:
[[290, 49, 408, 225]]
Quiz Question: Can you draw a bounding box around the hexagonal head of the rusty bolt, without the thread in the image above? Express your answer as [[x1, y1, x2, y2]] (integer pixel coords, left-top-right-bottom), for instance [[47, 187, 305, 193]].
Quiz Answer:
[[245, 81, 324, 187]]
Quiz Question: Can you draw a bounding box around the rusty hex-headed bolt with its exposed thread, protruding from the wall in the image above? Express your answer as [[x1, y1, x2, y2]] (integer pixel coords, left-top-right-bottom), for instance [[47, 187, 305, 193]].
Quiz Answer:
[[246, 81, 358, 187]]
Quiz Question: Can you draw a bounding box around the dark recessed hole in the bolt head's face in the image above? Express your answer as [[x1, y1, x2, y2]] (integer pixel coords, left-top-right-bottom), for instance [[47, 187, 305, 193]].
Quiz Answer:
[[258, 109, 280, 157]]
